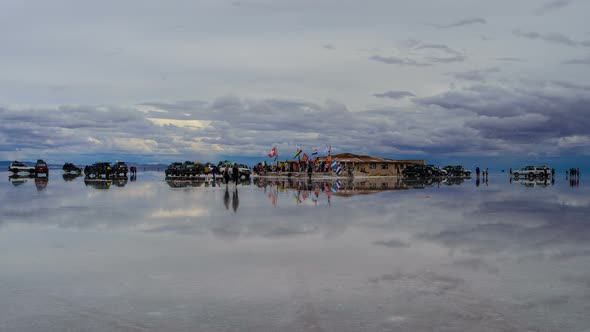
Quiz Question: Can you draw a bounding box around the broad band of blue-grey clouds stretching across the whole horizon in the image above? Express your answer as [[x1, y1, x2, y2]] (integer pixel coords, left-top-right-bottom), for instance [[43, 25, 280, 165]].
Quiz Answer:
[[0, 77, 590, 159]]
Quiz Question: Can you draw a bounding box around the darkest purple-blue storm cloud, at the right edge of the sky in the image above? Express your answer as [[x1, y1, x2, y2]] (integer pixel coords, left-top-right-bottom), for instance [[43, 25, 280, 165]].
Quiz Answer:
[[417, 83, 590, 144]]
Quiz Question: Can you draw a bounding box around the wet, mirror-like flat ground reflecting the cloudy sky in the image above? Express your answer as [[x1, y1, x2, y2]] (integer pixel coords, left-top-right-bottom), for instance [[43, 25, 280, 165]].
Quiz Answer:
[[0, 171, 590, 332]]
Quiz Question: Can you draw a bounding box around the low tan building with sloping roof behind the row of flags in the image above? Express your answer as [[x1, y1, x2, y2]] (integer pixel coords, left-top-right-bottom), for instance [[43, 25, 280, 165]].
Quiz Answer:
[[287, 153, 426, 176]]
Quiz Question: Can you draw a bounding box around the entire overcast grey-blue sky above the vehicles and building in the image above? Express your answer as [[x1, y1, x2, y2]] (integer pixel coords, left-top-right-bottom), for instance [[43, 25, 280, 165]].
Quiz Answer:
[[0, 0, 590, 167]]
